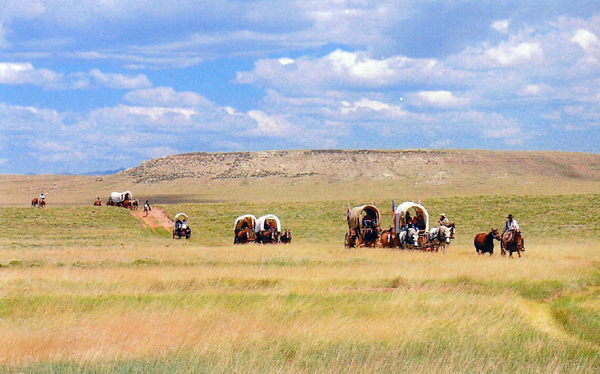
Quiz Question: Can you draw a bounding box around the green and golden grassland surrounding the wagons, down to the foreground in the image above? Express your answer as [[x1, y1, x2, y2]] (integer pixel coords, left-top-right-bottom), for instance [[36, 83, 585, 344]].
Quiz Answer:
[[0, 194, 600, 374]]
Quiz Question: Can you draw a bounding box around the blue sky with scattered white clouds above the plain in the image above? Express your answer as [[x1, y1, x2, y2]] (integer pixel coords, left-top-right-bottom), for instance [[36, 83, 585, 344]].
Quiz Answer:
[[0, 0, 600, 174]]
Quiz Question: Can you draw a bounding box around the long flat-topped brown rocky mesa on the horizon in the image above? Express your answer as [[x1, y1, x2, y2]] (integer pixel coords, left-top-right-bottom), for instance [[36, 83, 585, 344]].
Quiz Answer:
[[120, 150, 600, 183]]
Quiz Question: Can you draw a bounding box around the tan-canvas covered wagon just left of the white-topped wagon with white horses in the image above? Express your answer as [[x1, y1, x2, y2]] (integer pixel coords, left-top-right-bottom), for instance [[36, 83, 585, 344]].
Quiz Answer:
[[345, 205, 381, 247]]
